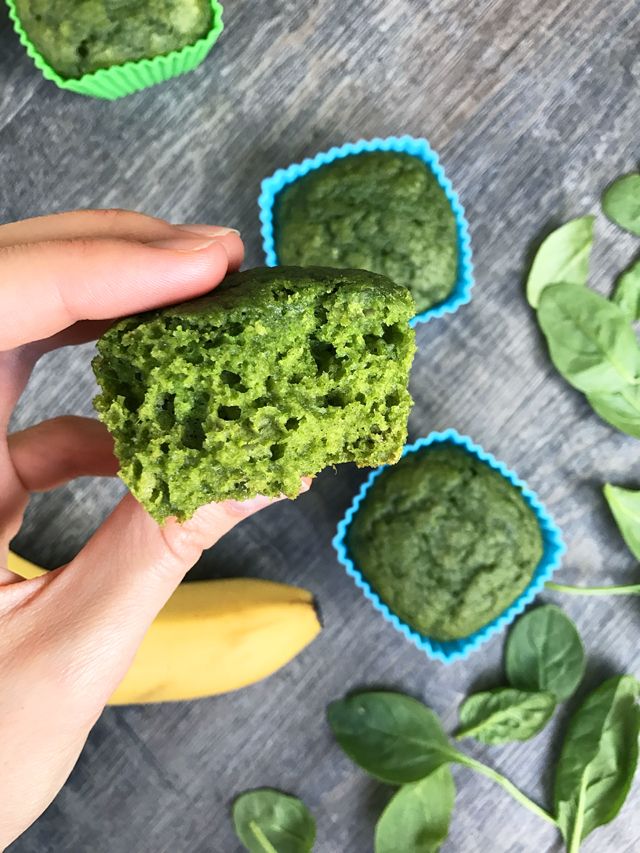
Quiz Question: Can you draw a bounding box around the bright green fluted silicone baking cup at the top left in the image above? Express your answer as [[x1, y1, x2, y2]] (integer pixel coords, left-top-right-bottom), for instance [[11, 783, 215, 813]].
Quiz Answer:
[[6, 0, 223, 101]]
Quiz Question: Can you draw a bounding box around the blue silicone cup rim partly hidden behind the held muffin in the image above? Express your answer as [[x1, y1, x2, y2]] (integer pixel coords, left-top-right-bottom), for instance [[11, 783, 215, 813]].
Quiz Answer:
[[258, 136, 473, 326]]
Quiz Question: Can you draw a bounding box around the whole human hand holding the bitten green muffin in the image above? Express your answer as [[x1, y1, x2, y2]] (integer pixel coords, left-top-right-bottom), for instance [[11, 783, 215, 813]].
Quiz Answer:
[[0, 211, 292, 849]]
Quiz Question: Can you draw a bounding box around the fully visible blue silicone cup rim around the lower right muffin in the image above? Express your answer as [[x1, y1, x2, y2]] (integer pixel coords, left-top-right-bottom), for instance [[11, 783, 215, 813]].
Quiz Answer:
[[333, 429, 566, 663]]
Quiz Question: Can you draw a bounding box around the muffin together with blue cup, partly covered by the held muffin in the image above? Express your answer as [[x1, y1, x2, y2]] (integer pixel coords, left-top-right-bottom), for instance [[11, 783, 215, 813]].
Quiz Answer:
[[259, 136, 473, 324]]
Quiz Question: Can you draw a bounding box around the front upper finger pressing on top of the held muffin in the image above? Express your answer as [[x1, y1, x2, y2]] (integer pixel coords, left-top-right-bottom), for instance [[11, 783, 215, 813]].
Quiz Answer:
[[0, 231, 243, 351]]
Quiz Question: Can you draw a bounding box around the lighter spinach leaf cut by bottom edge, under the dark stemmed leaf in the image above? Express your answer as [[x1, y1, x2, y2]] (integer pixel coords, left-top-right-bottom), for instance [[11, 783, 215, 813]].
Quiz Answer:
[[375, 765, 456, 853]]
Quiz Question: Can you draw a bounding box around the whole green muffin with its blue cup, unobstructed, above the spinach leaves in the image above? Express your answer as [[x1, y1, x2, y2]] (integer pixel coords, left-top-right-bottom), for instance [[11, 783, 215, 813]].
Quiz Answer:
[[333, 430, 564, 663]]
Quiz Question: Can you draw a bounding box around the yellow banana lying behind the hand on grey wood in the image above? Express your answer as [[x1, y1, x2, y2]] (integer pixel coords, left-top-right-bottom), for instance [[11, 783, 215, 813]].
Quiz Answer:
[[8, 553, 321, 705]]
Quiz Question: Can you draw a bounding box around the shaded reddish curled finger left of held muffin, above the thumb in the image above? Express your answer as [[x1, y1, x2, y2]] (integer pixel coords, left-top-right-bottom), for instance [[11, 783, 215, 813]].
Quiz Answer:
[[9, 415, 119, 492]]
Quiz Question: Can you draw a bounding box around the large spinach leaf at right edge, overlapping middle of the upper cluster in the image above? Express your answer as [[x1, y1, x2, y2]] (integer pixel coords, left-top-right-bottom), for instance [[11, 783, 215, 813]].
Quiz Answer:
[[538, 284, 640, 394]]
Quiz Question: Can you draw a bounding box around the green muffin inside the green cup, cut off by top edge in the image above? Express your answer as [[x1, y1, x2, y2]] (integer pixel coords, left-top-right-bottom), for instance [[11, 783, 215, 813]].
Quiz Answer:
[[16, 0, 213, 79]]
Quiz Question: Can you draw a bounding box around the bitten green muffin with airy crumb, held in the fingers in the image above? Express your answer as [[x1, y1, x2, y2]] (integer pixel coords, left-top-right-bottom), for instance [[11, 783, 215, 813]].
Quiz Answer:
[[93, 267, 415, 520]]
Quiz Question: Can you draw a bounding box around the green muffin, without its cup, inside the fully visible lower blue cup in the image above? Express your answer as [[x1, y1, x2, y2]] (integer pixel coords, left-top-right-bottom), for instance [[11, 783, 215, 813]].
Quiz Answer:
[[347, 444, 543, 641]]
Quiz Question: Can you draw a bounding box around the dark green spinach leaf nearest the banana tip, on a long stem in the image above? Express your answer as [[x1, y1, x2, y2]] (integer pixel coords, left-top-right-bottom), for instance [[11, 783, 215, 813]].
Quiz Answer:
[[327, 691, 458, 785]]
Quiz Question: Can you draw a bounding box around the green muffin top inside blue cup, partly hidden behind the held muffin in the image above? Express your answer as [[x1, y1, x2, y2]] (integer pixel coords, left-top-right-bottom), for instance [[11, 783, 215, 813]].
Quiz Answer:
[[274, 151, 458, 312]]
